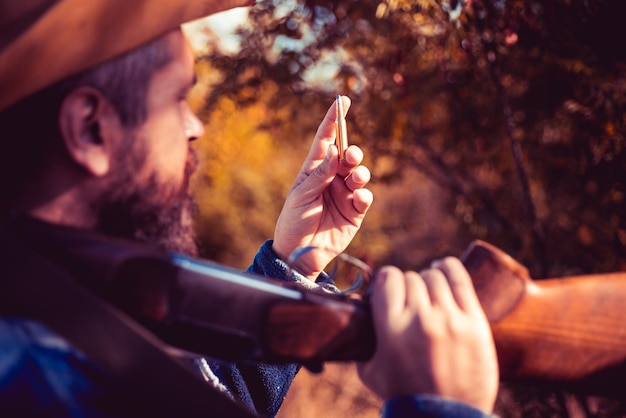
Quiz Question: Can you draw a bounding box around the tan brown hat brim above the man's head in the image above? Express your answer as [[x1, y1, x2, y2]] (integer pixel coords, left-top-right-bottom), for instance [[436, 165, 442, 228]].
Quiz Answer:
[[0, 0, 253, 111]]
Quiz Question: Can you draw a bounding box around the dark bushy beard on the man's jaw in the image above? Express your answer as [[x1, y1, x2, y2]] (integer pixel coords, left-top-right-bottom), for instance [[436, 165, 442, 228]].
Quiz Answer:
[[97, 147, 198, 256]]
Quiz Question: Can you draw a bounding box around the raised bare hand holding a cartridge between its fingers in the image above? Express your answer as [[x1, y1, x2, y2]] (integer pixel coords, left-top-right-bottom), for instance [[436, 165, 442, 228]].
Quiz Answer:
[[273, 96, 373, 280]]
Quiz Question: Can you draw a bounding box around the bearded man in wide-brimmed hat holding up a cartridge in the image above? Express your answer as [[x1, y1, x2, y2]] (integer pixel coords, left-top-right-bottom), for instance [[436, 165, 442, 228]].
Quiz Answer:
[[0, 0, 497, 417]]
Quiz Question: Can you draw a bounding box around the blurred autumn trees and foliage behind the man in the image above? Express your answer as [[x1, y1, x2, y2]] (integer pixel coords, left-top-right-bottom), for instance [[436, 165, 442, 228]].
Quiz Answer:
[[186, 0, 626, 418]]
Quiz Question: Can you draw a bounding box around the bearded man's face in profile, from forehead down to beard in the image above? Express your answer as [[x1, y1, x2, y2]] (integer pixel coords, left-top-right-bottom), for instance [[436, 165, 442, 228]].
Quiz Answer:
[[99, 31, 204, 255]]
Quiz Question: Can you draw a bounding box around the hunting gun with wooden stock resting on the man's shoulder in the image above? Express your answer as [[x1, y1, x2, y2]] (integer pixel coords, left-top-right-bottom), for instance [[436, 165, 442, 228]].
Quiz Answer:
[[50, 229, 626, 397]]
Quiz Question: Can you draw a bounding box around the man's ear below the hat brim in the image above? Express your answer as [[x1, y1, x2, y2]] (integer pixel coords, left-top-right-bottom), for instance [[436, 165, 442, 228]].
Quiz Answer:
[[59, 87, 124, 177]]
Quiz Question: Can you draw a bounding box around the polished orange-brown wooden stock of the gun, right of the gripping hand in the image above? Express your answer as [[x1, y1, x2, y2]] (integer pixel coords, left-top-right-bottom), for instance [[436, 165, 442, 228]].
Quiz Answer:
[[462, 241, 626, 396]]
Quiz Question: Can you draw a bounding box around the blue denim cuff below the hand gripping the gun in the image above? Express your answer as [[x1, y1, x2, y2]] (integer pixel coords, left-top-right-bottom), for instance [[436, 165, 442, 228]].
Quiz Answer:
[[382, 395, 495, 418]]
